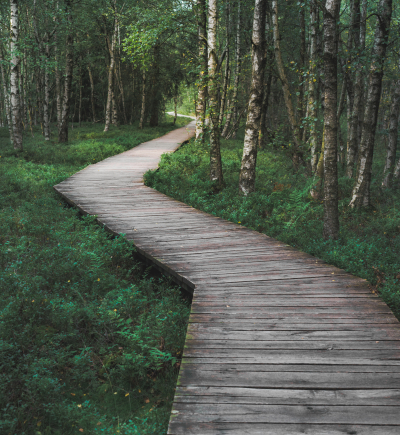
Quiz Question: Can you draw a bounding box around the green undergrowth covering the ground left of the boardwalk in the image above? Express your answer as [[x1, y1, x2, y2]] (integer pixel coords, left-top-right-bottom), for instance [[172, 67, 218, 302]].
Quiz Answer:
[[0, 118, 190, 435]]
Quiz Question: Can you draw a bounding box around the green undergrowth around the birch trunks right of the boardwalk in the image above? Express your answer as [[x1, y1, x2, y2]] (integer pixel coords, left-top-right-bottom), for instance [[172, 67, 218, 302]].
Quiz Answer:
[[145, 130, 400, 317]]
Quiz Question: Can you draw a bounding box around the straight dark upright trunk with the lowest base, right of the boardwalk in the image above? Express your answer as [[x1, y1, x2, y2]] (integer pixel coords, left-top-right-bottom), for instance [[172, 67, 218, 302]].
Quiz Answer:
[[324, 0, 341, 239]]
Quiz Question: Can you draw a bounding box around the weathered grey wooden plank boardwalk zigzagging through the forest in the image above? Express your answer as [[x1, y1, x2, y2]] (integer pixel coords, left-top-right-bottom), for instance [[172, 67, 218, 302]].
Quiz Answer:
[[55, 123, 400, 435]]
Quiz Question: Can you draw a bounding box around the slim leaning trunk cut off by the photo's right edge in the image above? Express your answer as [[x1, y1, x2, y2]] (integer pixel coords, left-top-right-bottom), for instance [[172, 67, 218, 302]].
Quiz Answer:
[[382, 58, 400, 187]]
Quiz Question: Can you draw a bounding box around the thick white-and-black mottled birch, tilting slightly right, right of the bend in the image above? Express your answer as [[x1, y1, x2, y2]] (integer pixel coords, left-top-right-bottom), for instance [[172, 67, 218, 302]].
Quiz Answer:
[[239, 0, 267, 195]]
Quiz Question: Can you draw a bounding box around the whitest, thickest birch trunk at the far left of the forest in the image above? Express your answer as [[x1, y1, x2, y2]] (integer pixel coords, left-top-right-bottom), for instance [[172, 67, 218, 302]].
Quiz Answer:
[[10, 0, 22, 150]]
